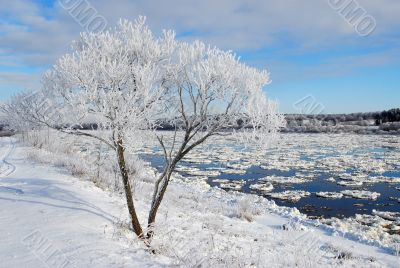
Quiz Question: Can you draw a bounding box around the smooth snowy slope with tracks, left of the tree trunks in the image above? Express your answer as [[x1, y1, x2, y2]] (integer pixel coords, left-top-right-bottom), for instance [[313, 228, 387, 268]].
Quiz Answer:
[[0, 139, 159, 267]]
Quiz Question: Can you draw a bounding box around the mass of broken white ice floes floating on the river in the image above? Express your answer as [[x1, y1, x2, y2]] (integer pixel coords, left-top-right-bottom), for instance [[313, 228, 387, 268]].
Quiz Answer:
[[131, 131, 400, 242]]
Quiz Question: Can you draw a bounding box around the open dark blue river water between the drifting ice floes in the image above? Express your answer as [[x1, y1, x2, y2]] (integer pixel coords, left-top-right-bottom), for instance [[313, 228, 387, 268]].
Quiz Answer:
[[143, 154, 400, 218]]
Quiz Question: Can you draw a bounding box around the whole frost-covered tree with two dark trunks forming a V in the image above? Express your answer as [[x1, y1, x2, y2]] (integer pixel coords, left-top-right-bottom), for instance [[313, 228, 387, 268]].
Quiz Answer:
[[2, 18, 284, 245]]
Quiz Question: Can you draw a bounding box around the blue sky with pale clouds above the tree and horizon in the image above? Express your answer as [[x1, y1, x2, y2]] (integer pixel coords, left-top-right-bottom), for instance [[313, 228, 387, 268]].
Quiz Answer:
[[0, 0, 400, 113]]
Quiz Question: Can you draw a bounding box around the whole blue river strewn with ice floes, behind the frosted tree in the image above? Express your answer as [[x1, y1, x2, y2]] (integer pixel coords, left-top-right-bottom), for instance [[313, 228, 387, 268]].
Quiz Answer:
[[119, 133, 400, 247]]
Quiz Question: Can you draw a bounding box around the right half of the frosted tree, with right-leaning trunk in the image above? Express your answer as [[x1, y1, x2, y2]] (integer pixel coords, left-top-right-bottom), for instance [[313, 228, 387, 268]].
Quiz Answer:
[[148, 41, 285, 237]]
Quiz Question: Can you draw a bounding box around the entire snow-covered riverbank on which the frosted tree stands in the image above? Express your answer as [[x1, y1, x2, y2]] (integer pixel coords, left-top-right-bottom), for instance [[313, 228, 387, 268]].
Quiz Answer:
[[0, 138, 400, 267]]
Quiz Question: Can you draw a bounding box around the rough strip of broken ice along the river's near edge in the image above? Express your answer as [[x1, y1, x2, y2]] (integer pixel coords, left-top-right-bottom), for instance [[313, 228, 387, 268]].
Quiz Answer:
[[25, 138, 400, 255]]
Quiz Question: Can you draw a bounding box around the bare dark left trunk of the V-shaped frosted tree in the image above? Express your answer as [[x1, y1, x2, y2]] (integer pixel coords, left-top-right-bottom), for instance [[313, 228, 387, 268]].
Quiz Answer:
[[117, 139, 144, 239]]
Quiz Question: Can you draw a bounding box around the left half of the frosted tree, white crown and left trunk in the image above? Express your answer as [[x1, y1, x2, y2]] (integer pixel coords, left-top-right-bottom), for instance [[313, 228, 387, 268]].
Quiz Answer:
[[35, 17, 175, 238]]
